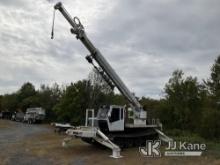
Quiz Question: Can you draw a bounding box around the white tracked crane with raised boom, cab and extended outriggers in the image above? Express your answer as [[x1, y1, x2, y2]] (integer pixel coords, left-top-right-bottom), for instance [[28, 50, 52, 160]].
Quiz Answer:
[[51, 2, 172, 158]]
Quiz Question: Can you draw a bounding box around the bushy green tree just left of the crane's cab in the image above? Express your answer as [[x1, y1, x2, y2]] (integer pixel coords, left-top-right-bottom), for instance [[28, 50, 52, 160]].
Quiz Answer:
[[54, 80, 90, 125]]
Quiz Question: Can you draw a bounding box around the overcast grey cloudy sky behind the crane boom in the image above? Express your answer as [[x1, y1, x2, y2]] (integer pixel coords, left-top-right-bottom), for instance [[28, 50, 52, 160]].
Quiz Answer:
[[0, 0, 220, 98]]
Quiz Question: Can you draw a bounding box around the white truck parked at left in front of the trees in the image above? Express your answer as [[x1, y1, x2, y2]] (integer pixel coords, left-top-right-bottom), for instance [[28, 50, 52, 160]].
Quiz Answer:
[[24, 107, 46, 124]]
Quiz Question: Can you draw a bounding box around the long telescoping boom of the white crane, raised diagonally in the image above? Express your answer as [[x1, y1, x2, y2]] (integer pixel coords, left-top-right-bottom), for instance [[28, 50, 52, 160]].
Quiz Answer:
[[54, 2, 142, 112]]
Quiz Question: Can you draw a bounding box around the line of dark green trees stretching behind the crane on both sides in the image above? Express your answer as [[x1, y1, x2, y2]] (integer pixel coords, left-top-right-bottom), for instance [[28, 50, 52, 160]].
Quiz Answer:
[[0, 56, 220, 139]]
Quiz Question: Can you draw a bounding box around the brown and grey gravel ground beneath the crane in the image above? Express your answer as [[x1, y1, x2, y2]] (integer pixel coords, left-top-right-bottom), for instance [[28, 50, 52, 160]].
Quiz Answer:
[[0, 120, 220, 165]]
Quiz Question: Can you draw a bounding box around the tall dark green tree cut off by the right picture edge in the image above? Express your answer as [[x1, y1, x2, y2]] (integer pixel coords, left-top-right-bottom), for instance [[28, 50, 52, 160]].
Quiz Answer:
[[200, 56, 220, 139]]
